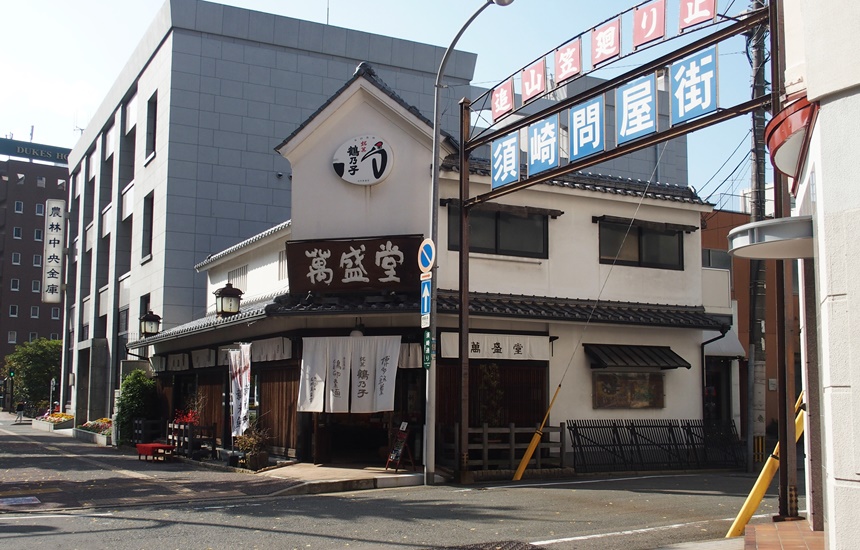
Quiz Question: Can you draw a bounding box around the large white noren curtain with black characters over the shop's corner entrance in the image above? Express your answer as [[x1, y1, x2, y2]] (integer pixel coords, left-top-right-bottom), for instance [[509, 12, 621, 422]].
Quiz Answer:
[[298, 336, 401, 413]]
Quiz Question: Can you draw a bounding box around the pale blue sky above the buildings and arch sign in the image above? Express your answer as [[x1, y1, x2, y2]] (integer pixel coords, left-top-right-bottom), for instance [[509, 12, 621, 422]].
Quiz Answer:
[[0, 0, 750, 209]]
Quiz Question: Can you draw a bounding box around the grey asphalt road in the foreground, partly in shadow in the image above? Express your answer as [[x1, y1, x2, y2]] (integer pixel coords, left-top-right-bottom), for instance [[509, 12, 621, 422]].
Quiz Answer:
[[0, 418, 805, 550]]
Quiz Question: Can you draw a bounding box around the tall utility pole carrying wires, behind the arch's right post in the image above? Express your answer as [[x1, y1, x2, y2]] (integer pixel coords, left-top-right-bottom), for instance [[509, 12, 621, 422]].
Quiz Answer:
[[746, 0, 767, 472]]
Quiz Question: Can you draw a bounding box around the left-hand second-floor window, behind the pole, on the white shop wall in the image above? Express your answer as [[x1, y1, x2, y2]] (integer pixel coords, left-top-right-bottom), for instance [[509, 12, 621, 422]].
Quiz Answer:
[[448, 205, 549, 258]]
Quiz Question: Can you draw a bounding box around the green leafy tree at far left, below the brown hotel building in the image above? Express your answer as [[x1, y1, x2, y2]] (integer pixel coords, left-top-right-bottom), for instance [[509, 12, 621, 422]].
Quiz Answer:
[[3, 338, 63, 403]]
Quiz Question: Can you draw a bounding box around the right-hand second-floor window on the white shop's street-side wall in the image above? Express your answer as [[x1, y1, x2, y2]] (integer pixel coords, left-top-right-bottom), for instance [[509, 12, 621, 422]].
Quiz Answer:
[[600, 220, 684, 270]]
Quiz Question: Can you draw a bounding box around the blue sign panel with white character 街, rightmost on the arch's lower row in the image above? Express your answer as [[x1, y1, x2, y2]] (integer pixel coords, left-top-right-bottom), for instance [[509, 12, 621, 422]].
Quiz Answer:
[[669, 46, 717, 124]]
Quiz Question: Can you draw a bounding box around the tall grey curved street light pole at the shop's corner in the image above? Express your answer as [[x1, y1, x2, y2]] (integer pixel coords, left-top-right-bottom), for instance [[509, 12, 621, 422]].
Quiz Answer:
[[424, 0, 514, 485]]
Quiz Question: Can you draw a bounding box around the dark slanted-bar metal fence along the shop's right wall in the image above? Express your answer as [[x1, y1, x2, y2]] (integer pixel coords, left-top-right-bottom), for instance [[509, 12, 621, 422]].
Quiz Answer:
[[567, 420, 746, 472]]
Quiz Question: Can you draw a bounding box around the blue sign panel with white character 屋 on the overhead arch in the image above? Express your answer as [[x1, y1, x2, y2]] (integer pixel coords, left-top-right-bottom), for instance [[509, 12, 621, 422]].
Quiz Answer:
[[615, 74, 657, 143]]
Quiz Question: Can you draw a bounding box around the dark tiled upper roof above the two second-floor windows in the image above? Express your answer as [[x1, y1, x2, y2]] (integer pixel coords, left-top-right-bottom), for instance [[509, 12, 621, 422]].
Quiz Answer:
[[442, 155, 708, 205]]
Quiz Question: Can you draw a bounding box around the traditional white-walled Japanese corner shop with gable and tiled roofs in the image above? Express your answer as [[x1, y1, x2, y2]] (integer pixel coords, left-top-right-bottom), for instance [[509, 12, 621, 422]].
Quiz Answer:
[[130, 65, 737, 468]]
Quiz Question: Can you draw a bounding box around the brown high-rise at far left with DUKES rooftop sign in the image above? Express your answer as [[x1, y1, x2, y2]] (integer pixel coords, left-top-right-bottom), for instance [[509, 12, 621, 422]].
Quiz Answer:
[[0, 139, 69, 408]]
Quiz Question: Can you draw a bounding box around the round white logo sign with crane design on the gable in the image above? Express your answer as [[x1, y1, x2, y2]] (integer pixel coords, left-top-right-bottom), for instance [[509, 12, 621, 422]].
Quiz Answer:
[[332, 136, 394, 185]]
